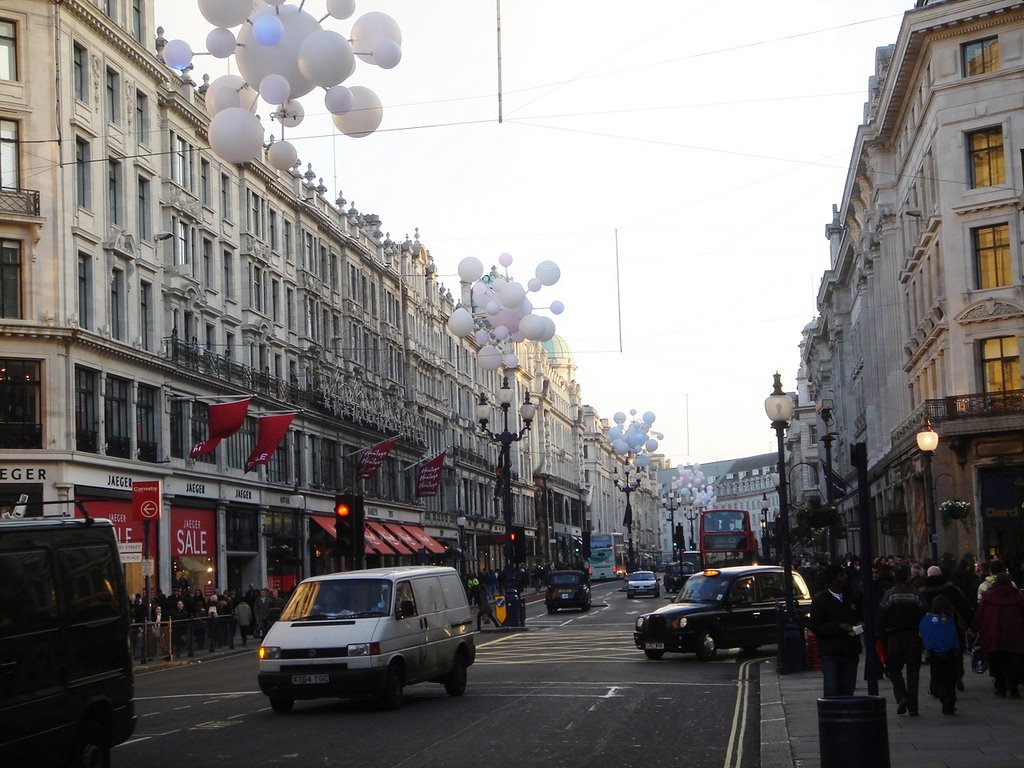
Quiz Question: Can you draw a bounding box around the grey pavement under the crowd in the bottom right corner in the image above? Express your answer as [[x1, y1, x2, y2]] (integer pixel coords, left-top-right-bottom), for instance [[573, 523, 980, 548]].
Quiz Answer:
[[759, 659, 1024, 768]]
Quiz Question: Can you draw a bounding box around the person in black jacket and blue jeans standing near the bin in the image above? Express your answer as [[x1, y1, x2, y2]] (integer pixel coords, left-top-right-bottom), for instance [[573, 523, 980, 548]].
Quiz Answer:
[[811, 563, 863, 697]]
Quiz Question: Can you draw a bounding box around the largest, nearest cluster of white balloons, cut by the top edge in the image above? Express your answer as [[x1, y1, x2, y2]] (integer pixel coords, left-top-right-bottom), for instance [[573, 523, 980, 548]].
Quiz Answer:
[[163, 0, 401, 165]]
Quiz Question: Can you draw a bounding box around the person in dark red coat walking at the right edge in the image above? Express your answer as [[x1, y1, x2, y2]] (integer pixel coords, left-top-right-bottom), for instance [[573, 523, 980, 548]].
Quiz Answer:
[[971, 560, 1024, 698]]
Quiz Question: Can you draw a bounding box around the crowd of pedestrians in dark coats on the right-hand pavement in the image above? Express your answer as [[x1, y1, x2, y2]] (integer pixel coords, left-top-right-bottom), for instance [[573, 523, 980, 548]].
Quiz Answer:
[[800, 555, 1024, 717]]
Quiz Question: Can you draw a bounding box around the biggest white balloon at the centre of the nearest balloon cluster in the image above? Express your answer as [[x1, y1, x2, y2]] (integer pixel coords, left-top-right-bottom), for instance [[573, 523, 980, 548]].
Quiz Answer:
[[234, 5, 321, 98]]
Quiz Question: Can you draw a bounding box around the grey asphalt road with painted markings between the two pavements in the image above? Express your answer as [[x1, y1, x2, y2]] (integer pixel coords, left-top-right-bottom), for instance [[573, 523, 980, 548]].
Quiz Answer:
[[119, 584, 771, 768]]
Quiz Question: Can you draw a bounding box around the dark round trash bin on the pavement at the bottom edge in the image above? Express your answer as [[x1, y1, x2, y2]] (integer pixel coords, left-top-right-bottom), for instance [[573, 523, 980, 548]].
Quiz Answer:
[[818, 696, 890, 768]]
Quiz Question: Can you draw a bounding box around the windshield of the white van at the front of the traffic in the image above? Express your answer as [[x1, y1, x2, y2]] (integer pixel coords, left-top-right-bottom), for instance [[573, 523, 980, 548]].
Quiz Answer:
[[281, 579, 392, 622]]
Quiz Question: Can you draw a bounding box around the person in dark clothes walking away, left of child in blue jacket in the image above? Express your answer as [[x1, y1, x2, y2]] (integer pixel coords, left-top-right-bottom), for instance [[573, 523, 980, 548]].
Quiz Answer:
[[877, 564, 926, 717]]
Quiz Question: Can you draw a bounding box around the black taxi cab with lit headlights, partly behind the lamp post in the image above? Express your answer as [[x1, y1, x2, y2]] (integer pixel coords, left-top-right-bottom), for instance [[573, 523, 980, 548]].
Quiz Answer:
[[633, 565, 811, 660]]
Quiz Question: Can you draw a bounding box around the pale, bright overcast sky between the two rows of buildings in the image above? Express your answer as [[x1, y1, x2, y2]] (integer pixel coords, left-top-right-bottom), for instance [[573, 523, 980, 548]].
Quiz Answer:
[[163, 0, 913, 465]]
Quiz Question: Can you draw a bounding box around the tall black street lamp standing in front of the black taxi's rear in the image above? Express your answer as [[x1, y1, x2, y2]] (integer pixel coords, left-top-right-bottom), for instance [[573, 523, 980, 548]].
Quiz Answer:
[[765, 372, 807, 675]]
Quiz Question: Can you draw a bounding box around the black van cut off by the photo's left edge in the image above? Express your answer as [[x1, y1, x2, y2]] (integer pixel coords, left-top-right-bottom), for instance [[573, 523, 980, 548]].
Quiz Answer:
[[0, 518, 135, 768]]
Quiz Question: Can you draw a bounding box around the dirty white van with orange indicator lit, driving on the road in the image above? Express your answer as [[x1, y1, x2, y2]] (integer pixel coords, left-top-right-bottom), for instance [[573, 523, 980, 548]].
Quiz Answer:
[[258, 565, 476, 713]]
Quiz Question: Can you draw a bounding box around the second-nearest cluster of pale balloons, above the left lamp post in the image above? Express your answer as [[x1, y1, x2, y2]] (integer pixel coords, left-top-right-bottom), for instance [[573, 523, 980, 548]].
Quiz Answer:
[[447, 253, 565, 371]]
